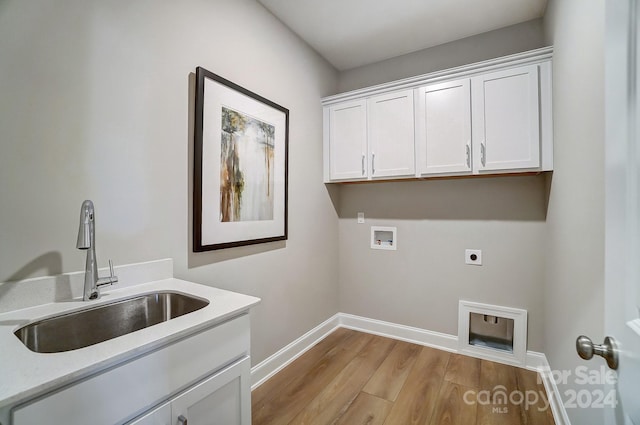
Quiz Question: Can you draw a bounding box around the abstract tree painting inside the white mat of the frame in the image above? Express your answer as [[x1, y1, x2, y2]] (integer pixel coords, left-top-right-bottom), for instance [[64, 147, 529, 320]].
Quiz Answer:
[[220, 106, 275, 222]]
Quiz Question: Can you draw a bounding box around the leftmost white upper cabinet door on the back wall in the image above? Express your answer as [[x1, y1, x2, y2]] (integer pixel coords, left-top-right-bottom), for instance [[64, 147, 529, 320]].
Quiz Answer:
[[329, 100, 367, 180]]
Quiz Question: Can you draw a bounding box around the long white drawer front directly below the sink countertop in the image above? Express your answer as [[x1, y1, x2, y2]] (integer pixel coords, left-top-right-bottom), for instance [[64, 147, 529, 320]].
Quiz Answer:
[[12, 314, 249, 425]]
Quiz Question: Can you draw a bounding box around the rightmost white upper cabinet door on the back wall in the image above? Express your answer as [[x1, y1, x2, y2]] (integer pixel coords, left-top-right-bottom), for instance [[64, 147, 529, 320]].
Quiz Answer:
[[472, 65, 540, 172]]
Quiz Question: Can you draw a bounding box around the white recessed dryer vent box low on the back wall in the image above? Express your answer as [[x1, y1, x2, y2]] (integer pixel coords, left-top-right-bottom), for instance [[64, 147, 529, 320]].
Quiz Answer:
[[458, 300, 527, 367]]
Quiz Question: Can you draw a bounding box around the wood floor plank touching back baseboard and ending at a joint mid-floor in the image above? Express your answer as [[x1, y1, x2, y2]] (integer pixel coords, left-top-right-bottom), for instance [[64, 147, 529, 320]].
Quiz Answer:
[[363, 341, 422, 401]]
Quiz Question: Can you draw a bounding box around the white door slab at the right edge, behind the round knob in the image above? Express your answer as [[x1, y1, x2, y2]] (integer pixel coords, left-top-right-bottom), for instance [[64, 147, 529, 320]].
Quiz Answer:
[[596, 0, 640, 425]]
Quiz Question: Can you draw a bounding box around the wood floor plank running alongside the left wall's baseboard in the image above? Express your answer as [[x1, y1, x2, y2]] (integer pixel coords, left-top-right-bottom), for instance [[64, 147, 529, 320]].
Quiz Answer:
[[251, 328, 354, 406]]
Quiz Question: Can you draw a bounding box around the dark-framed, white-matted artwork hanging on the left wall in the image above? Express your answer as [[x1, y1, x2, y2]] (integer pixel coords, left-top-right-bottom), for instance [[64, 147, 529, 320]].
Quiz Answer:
[[193, 67, 289, 252]]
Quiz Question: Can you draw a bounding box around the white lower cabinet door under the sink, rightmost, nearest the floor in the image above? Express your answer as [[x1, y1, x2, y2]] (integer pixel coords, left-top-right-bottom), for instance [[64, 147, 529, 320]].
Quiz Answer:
[[171, 356, 251, 425]]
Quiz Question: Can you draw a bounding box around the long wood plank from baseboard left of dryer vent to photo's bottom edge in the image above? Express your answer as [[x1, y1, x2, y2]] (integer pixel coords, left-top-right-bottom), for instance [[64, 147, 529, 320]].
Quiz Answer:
[[385, 347, 450, 425]]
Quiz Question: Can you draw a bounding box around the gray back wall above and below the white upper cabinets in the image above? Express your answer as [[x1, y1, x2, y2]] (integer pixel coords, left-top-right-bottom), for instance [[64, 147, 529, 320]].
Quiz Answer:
[[338, 20, 547, 351]]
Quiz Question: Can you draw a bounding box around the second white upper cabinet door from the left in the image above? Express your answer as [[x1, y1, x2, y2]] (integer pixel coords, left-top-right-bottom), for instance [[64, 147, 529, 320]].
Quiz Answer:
[[368, 90, 415, 178]]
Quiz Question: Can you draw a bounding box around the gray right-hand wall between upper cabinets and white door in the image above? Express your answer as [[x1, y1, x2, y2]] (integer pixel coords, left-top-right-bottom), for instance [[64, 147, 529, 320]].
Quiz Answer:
[[544, 0, 605, 425]]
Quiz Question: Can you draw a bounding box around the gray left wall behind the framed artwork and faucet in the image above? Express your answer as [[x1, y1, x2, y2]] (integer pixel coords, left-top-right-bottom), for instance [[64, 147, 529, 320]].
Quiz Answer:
[[0, 0, 338, 363]]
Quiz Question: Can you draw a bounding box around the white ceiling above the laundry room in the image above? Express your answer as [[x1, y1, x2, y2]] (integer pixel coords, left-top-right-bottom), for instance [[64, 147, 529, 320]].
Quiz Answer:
[[258, 0, 547, 71]]
